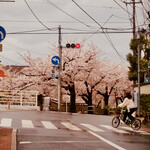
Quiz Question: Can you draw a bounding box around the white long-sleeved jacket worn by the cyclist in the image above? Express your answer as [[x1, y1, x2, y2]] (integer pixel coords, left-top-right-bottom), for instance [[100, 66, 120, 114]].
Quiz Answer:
[[118, 98, 135, 111]]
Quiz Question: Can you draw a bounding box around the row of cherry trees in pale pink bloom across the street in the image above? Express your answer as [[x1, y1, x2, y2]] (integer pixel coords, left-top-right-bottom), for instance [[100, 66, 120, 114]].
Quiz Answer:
[[0, 40, 131, 113]]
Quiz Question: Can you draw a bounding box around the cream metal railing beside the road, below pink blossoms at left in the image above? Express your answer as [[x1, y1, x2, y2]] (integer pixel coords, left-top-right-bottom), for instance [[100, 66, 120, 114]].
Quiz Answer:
[[0, 90, 38, 106]]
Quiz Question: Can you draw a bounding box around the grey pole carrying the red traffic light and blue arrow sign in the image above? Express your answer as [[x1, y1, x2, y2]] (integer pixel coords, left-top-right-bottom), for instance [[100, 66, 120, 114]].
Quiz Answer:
[[58, 26, 62, 111]]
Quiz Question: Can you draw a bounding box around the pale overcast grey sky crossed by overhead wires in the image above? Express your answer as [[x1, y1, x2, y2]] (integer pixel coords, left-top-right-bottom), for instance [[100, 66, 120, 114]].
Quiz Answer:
[[0, 0, 150, 65]]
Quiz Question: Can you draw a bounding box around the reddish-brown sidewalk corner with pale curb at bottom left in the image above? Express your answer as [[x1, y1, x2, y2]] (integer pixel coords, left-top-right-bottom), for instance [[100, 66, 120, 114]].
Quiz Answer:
[[0, 127, 16, 150]]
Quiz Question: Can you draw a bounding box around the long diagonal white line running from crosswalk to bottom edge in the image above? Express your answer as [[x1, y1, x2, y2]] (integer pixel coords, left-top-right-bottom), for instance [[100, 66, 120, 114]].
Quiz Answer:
[[87, 131, 126, 150]]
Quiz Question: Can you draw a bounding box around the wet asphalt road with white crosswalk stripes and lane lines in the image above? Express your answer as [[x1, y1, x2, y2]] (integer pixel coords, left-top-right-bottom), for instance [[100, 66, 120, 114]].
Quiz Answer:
[[0, 111, 150, 150]]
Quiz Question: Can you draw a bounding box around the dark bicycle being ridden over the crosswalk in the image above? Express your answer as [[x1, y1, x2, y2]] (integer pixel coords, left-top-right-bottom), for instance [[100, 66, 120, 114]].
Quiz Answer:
[[112, 109, 141, 130]]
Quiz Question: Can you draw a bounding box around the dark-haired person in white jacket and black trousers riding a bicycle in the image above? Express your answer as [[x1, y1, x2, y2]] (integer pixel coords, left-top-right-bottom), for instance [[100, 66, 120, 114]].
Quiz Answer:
[[118, 93, 137, 122]]
